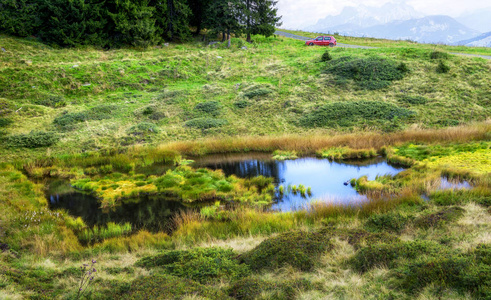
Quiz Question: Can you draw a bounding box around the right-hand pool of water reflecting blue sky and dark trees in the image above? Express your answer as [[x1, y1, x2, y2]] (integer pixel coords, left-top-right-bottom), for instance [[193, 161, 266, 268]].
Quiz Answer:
[[194, 157, 404, 211]]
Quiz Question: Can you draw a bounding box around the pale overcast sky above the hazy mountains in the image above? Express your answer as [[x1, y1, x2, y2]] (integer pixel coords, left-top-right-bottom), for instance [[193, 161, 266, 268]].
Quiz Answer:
[[277, 0, 490, 29]]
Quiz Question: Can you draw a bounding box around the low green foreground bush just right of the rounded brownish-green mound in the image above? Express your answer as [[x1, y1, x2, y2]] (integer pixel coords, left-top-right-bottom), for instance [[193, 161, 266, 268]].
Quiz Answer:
[[350, 241, 441, 272]]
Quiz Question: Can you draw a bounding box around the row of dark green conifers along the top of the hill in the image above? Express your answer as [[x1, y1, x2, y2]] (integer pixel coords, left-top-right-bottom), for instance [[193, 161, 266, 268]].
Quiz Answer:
[[0, 0, 281, 48]]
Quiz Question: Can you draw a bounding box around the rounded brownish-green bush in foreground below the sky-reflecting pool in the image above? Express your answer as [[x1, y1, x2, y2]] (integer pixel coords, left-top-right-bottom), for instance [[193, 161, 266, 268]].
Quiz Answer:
[[241, 231, 332, 271]]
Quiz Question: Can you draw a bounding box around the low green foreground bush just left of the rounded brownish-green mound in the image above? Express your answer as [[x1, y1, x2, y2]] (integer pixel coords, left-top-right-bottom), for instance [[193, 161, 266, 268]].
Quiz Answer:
[[137, 248, 249, 283]]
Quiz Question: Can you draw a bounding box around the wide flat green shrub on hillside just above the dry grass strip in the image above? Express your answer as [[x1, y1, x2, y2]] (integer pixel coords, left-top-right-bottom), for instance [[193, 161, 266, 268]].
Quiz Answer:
[[300, 101, 415, 127]]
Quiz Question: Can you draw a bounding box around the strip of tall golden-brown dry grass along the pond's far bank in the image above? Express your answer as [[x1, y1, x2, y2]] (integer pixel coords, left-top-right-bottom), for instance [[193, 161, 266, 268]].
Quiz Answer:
[[157, 122, 491, 156]]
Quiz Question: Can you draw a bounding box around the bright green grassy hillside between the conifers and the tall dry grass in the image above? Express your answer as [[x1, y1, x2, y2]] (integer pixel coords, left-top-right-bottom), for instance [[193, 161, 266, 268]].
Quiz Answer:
[[0, 36, 491, 161]]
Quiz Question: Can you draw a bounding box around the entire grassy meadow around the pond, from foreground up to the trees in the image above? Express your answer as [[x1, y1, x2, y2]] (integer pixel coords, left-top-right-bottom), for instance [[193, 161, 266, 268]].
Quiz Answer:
[[0, 33, 491, 299]]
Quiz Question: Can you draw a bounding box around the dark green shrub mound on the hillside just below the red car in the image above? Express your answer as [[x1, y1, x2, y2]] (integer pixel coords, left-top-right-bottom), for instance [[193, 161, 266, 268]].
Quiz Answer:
[[325, 56, 409, 90]]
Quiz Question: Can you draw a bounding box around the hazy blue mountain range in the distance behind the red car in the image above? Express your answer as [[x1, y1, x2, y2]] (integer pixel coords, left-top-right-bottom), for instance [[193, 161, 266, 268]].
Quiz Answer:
[[304, 3, 491, 47]]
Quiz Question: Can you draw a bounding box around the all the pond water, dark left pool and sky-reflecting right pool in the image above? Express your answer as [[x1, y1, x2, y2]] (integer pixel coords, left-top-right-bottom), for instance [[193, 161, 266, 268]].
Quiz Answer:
[[46, 153, 403, 232]]
